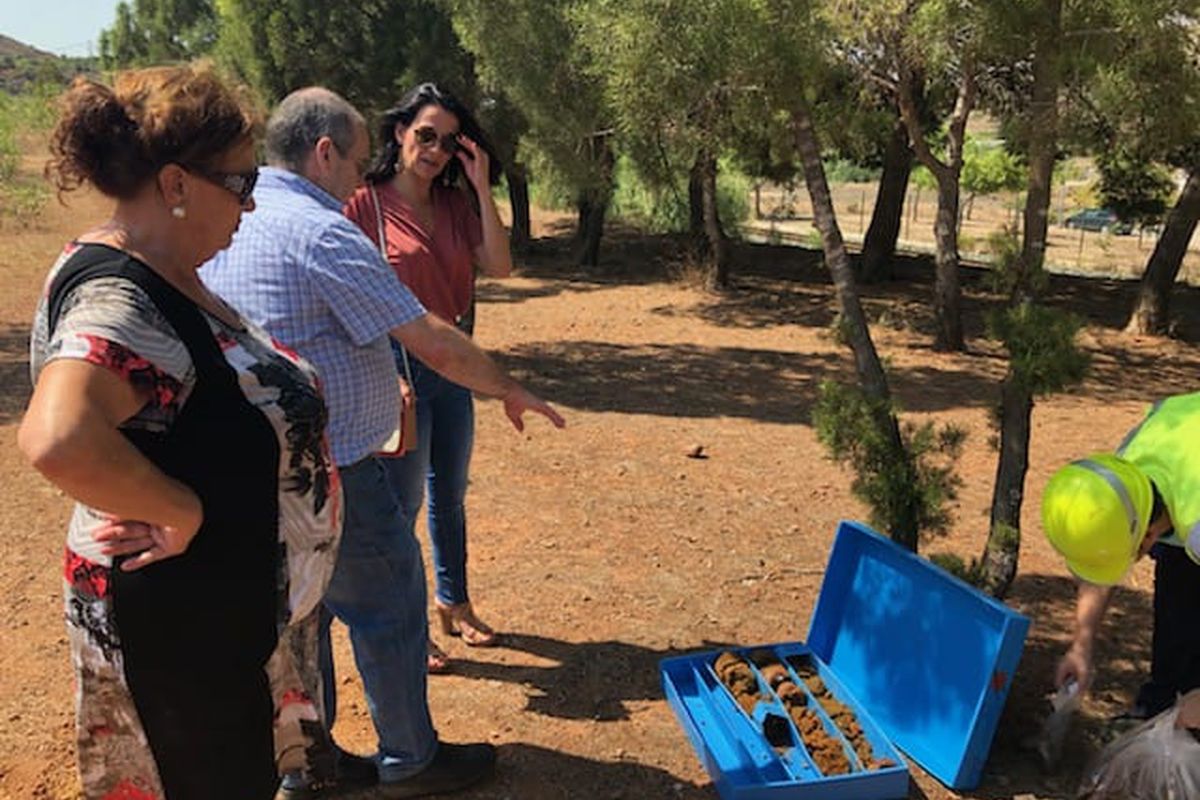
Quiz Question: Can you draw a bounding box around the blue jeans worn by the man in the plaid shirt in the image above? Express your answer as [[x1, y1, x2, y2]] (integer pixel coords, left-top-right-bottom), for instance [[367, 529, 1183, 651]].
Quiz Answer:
[[319, 458, 437, 782]]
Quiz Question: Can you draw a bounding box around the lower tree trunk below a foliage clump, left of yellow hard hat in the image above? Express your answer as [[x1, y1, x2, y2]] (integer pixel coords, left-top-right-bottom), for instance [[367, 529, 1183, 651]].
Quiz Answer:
[[980, 368, 1033, 600]]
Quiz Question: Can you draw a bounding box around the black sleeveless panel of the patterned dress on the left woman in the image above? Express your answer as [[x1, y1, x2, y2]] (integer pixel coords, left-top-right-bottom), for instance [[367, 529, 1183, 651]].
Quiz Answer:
[[49, 245, 281, 800]]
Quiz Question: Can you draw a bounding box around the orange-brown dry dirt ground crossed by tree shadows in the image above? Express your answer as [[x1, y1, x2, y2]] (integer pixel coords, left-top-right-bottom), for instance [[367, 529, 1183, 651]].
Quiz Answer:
[[0, 183, 1200, 800]]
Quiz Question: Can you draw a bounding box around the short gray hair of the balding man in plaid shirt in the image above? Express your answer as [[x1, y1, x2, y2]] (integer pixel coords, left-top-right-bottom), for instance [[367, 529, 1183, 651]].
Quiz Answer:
[[265, 86, 366, 173]]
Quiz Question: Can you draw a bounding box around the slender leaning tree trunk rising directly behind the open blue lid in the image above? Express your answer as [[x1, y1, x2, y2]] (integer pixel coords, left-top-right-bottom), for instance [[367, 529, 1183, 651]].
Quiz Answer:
[[792, 106, 918, 552]]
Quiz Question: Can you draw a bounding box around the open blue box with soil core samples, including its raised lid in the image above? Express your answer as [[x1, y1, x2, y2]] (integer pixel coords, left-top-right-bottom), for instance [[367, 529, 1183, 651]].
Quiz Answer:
[[661, 522, 1028, 800]]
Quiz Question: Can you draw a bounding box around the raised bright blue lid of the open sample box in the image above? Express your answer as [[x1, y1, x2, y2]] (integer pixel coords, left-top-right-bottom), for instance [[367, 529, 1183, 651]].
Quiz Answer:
[[808, 522, 1030, 789]]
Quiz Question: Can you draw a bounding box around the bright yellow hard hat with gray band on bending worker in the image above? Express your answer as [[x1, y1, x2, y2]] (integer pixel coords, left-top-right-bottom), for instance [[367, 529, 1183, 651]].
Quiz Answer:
[[1042, 453, 1154, 587]]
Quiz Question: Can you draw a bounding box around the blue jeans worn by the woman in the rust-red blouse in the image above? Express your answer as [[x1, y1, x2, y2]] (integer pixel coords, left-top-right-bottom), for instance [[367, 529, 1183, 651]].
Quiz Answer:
[[382, 343, 475, 606]]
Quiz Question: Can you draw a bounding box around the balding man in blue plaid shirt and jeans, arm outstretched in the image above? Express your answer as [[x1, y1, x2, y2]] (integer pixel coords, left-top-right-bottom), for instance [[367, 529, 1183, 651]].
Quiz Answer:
[[200, 88, 564, 800]]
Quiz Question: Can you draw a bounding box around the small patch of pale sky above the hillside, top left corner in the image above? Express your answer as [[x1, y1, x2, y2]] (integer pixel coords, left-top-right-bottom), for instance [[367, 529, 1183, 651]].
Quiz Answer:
[[0, 0, 119, 55]]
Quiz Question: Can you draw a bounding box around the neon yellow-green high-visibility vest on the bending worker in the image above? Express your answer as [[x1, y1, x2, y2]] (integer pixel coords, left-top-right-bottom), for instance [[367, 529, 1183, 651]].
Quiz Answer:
[[1117, 392, 1200, 564]]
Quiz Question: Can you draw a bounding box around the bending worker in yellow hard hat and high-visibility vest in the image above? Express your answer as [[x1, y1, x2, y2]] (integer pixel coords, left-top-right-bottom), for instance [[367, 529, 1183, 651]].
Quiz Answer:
[[1042, 392, 1200, 718]]
